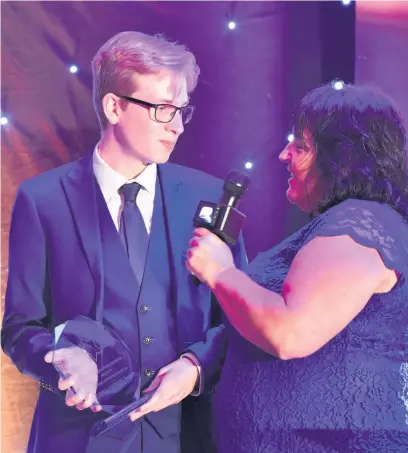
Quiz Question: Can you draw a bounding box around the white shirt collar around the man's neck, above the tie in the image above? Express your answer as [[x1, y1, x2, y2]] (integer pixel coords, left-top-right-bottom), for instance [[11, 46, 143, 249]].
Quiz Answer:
[[92, 145, 157, 201]]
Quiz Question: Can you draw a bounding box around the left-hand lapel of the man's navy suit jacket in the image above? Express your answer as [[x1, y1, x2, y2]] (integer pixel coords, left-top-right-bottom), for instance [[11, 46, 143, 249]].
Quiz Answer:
[[62, 152, 104, 321]]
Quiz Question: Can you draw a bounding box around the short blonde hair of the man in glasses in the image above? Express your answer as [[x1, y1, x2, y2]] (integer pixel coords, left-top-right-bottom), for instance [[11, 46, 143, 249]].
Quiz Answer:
[[92, 31, 200, 130]]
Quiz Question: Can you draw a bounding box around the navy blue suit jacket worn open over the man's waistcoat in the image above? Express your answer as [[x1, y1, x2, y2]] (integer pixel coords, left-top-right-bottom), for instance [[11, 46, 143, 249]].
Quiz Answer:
[[1, 153, 246, 453]]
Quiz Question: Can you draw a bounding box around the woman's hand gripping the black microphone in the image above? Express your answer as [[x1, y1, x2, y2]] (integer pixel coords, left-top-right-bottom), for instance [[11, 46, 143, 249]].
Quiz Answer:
[[186, 228, 235, 288]]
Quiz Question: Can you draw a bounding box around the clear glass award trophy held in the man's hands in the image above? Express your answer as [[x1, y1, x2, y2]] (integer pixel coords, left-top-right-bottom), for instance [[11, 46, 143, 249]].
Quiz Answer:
[[53, 316, 140, 414]]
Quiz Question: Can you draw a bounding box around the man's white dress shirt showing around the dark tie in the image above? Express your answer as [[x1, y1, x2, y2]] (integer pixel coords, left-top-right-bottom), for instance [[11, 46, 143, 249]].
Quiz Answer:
[[92, 146, 157, 234]]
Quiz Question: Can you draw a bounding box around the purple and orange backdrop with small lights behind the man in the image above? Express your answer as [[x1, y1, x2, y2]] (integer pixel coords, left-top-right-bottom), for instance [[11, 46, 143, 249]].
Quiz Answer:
[[1, 1, 354, 453]]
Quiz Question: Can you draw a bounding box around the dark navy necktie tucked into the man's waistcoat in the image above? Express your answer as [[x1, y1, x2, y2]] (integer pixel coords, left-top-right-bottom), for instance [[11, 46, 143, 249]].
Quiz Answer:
[[119, 182, 149, 286]]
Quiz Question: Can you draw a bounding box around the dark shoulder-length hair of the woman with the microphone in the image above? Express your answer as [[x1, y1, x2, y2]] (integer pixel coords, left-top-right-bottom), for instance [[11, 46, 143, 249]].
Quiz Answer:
[[294, 83, 408, 220]]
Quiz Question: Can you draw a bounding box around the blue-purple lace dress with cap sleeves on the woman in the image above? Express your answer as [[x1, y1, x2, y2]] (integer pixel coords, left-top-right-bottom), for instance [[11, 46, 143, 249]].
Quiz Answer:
[[214, 199, 408, 453]]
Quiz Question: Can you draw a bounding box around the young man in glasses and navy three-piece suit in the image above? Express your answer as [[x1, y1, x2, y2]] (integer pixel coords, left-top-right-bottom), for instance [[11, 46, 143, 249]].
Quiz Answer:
[[2, 32, 246, 453]]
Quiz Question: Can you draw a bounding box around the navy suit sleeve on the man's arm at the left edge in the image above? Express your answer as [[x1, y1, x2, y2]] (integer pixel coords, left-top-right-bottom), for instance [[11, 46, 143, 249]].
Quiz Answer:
[[1, 187, 58, 390]]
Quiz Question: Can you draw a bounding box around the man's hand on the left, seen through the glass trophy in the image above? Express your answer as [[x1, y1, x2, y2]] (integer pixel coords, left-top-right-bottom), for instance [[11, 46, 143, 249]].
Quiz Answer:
[[44, 346, 102, 412]]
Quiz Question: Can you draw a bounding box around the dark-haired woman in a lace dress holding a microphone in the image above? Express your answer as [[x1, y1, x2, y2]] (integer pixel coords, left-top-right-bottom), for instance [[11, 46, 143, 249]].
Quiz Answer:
[[187, 85, 408, 453]]
